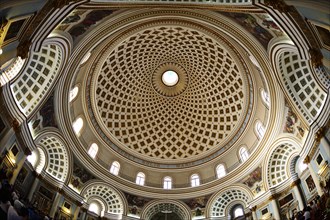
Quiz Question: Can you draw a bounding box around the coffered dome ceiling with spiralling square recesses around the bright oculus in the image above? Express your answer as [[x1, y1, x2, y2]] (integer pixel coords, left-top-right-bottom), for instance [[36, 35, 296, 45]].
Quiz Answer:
[[88, 21, 249, 163]]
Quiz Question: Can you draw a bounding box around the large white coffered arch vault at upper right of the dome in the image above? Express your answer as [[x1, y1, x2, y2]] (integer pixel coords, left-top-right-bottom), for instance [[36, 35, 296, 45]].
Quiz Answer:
[[272, 45, 327, 124]]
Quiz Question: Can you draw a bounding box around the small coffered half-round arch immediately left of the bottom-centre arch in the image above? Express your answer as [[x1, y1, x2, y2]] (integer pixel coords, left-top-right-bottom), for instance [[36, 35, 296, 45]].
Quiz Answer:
[[80, 181, 127, 215]]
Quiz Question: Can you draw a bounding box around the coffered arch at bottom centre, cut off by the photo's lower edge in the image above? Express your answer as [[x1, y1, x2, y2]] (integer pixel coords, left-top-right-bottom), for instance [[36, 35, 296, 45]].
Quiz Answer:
[[141, 200, 191, 220]]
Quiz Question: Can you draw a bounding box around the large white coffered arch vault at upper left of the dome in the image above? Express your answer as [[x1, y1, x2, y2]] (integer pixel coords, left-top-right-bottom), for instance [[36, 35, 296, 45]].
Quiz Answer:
[[10, 41, 66, 116]]
